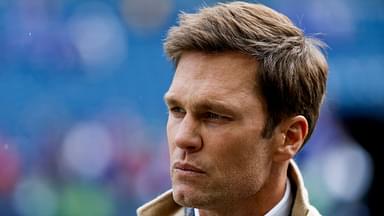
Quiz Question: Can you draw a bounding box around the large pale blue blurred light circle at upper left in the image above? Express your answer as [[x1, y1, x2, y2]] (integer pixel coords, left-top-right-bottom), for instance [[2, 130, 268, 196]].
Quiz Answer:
[[68, 3, 127, 73]]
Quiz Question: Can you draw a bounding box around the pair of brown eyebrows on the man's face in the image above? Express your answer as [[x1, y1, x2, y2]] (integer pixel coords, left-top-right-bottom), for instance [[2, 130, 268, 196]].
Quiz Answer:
[[164, 93, 239, 115]]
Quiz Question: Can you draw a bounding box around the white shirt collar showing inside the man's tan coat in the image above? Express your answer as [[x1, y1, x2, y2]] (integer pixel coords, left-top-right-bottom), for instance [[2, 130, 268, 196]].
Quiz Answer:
[[194, 178, 292, 216]]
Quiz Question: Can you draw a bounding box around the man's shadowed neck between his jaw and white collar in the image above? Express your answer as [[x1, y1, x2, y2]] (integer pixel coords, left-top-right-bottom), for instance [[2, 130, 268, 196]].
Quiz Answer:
[[199, 163, 288, 216]]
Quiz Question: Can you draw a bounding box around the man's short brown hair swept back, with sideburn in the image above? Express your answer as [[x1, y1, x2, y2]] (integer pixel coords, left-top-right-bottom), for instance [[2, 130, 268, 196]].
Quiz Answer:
[[164, 2, 328, 141]]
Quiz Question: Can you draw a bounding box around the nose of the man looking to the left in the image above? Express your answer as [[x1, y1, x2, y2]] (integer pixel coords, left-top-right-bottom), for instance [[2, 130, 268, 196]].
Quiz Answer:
[[174, 114, 203, 153]]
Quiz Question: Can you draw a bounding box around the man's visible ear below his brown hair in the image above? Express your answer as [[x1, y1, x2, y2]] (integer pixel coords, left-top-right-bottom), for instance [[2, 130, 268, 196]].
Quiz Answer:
[[274, 115, 308, 162]]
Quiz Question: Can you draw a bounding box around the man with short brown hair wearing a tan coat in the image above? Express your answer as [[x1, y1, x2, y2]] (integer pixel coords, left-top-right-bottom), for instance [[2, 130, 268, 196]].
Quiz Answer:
[[137, 2, 328, 216]]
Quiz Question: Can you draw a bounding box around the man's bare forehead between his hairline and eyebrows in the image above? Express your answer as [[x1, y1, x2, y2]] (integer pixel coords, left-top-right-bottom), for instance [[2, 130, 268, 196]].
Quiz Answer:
[[166, 52, 257, 107]]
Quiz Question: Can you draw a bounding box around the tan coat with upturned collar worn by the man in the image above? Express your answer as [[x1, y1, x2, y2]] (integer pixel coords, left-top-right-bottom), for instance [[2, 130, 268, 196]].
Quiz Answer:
[[137, 160, 320, 216]]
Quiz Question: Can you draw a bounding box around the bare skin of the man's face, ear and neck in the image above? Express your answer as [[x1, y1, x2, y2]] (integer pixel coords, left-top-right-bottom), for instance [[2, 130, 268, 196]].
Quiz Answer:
[[165, 51, 308, 216]]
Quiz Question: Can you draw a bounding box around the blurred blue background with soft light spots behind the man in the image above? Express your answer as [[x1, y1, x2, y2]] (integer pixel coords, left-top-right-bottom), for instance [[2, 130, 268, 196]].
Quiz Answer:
[[0, 0, 384, 216]]
